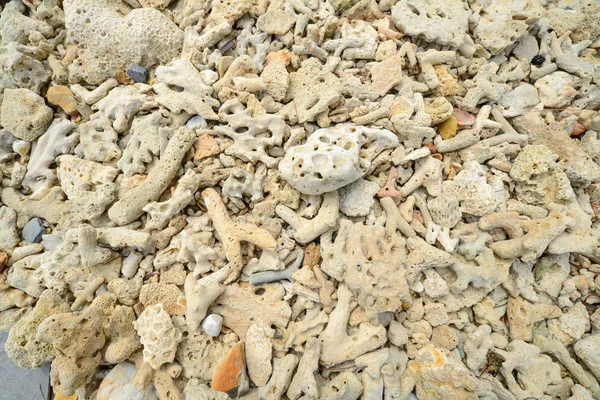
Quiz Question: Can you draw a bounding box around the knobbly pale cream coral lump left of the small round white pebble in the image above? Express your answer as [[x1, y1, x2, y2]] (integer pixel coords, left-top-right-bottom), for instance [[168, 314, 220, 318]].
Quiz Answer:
[[133, 304, 182, 369]]
